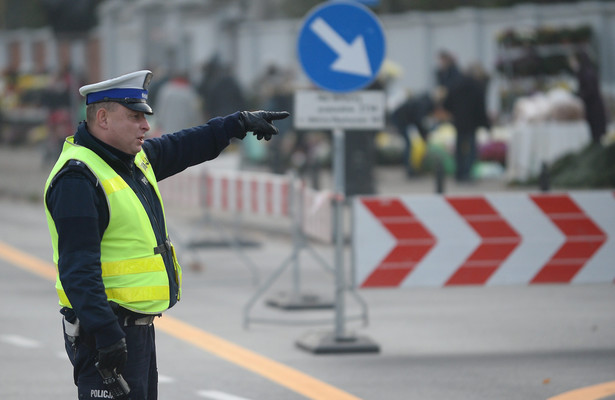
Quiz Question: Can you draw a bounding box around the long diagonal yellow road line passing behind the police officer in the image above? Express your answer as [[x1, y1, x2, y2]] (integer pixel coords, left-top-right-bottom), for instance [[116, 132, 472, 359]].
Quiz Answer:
[[0, 241, 360, 400]]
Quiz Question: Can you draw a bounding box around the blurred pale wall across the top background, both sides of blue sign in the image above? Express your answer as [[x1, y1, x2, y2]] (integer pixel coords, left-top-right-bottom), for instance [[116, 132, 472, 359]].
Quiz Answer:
[[0, 0, 615, 104]]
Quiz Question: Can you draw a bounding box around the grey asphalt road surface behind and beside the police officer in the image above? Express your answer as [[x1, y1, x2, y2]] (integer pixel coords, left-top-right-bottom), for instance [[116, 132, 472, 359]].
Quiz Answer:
[[0, 199, 615, 400]]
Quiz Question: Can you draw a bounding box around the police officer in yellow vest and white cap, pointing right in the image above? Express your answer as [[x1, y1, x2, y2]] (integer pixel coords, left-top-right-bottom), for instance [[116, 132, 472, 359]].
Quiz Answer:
[[45, 70, 289, 400]]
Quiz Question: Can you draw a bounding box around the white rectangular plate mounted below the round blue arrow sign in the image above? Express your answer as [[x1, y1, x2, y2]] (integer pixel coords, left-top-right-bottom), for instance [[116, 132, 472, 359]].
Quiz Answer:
[[294, 90, 385, 130]]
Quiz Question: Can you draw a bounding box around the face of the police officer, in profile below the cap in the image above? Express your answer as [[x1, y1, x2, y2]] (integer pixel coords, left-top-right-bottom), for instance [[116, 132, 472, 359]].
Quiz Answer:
[[107, 105, 150, 155]]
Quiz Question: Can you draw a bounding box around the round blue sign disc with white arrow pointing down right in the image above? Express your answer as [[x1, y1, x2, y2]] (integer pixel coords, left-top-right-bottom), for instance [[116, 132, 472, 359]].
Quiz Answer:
[[297, 1, 385, 92]]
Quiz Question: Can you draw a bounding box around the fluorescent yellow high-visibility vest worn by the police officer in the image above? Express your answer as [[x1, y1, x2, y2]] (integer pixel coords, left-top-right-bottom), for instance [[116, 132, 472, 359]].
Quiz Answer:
[[45, 136, 182, 314]]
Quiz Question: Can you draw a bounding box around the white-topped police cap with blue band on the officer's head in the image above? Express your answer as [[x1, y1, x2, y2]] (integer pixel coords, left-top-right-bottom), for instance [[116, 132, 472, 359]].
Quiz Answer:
[[79, 70, 154, 115]]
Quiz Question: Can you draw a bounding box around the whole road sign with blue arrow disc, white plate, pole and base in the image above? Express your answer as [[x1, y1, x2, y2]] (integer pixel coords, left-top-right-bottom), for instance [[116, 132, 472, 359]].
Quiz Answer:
[[294, 1, 385, 354]]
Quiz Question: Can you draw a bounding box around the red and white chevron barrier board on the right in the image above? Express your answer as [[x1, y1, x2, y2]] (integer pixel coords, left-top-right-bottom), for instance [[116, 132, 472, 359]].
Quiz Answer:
[[353, 191, 615, 287]]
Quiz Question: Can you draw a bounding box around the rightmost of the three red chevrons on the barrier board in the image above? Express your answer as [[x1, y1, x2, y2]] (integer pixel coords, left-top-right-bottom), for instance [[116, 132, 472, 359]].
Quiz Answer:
[[530, 194, 606, 283]]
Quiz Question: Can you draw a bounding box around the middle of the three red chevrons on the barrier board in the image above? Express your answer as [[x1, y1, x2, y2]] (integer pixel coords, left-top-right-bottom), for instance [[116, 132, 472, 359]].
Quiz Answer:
[[445, 197, 521, 285]]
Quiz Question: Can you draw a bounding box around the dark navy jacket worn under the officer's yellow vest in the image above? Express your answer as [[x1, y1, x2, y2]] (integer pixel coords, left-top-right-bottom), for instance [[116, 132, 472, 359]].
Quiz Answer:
[[46, 113, 244, 348]]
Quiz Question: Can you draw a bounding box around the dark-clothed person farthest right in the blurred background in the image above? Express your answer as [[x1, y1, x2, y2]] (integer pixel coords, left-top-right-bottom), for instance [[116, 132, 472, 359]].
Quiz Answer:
[[569, 50, 607, 144]]
